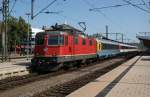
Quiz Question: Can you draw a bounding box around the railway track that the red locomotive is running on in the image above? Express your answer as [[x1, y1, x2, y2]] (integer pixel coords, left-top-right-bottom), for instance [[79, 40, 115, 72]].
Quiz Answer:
[[0, 56, 116, 92]]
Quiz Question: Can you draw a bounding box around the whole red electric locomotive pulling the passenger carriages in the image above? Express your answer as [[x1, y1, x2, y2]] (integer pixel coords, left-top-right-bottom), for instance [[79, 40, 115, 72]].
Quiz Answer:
[[32, 24, 96, 71]]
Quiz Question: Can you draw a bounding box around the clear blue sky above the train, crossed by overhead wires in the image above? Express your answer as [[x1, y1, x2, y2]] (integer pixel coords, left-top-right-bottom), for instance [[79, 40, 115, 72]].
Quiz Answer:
[[0, 0, 150, 41]]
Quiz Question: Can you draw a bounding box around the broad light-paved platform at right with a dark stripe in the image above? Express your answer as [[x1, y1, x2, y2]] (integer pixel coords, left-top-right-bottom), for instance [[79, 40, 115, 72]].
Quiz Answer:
[[67, 55, 150, 97]]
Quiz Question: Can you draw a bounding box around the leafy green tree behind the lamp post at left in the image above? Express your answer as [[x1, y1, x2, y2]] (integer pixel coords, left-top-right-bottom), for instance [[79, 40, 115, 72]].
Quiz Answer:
[[8, 17, 30, 48]]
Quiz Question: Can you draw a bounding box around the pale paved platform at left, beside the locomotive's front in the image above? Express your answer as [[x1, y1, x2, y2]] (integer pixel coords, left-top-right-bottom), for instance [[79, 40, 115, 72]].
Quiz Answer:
[[0, 58, 31, 80]]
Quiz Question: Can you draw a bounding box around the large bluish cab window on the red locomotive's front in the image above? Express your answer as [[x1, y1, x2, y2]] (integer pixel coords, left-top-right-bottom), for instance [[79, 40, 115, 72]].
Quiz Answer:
[[48, 35, 64, 45]]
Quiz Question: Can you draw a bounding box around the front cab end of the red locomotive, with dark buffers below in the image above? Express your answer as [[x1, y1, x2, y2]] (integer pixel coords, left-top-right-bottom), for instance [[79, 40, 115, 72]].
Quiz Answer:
[[32, 32, 64, 71]]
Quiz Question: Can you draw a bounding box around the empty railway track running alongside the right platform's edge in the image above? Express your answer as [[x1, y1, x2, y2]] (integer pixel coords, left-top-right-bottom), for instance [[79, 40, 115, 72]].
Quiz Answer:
[[33, 60, 125, 97]]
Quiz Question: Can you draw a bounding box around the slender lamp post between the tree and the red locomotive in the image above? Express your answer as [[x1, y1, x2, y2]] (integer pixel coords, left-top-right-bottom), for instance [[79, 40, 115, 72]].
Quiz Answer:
[[25, 13, 31, 60]]
